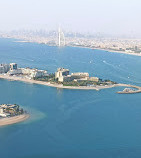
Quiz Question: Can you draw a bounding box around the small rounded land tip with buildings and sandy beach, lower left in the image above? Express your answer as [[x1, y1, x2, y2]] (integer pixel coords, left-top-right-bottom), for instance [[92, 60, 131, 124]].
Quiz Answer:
[[0, 104, 29, 127]]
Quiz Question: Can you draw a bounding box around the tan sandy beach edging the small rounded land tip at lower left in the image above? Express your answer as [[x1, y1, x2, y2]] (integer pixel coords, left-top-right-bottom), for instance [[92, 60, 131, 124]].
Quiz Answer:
[[0, 114, 30, 127]]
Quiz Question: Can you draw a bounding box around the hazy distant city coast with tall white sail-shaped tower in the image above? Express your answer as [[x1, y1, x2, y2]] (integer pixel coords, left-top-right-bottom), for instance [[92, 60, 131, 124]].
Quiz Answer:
[[0, 28, 141, 55]]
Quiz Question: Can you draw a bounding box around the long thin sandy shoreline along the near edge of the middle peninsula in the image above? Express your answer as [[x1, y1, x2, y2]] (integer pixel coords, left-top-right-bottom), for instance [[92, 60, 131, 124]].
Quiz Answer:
[[0, 75, 141, 94]]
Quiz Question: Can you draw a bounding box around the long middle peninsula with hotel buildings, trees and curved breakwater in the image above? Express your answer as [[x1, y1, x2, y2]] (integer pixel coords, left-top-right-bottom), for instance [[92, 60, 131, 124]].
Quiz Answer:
[[0, 63, 141, 94]]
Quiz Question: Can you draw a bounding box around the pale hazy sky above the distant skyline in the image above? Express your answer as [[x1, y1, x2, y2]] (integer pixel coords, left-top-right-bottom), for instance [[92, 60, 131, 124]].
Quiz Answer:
[[0, 0, 141, 34]]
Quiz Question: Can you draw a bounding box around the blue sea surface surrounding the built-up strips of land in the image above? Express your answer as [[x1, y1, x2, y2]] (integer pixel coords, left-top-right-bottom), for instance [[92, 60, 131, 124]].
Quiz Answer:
[[0, 39, 141, 158]]
